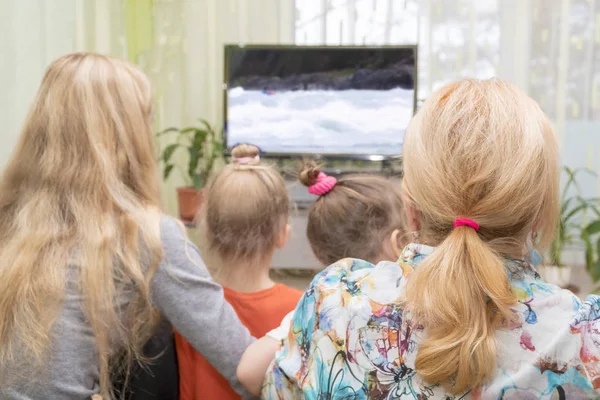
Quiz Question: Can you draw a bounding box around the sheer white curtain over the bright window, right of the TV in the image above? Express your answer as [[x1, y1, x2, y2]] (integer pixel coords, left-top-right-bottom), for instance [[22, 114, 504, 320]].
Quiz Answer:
[[296, 0, 600, 196]]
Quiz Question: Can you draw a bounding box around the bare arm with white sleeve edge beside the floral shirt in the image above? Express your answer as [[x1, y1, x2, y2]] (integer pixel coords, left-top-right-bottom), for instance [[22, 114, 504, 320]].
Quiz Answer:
[[237, 311, 294, 396]]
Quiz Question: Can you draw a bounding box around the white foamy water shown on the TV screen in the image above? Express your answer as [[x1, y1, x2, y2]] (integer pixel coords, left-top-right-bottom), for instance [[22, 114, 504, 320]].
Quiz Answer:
[[227, 87, 414, 155]]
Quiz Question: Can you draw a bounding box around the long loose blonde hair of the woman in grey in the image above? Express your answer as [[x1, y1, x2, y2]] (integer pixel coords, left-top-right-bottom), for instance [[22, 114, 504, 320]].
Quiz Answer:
[[0, 53, 162, 399]]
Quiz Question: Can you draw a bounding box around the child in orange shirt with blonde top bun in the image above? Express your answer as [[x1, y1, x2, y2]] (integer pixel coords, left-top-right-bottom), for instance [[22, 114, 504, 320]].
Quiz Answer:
[[175, 144, 302, 400]]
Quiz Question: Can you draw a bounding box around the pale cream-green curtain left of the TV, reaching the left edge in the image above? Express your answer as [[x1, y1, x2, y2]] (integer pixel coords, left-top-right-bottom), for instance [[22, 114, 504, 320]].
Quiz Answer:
[[0, 0, 294, 214]]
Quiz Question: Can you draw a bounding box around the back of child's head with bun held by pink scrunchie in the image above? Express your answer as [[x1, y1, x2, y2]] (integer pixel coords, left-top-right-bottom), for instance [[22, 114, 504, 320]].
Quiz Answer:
[[298, 160, 405, 265]]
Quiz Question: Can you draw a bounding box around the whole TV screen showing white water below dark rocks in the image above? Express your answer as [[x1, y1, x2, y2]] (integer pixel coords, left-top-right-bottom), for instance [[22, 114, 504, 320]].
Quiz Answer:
[[225, 46, 417, 156]]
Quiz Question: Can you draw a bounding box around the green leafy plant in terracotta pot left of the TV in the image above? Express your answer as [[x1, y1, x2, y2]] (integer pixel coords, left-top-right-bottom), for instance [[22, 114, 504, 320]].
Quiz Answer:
[[157, 119, 223, 222]]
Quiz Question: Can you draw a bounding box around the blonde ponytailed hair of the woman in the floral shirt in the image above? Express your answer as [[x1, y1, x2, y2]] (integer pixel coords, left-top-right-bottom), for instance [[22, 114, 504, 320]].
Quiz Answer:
[[404, 79, 558, 393]]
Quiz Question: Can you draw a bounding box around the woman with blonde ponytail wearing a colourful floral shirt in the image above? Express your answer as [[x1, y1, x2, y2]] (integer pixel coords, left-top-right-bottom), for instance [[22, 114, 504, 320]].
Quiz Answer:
[[263, 79, 600, 399]]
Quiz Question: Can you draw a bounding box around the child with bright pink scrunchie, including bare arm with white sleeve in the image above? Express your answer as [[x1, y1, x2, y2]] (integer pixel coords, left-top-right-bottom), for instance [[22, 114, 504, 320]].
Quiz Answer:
[[238, 160, 407, 394]]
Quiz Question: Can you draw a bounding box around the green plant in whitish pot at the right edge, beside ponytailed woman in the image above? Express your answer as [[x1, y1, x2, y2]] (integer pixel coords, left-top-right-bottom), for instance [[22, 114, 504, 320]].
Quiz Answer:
[[540, 167, 600, 287]]
